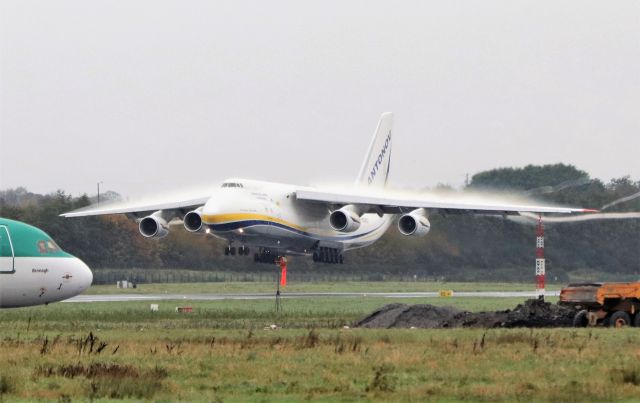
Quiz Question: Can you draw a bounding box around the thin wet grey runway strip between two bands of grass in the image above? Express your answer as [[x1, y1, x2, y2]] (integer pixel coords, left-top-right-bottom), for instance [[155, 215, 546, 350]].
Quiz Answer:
[[64, 291, 560, 302]]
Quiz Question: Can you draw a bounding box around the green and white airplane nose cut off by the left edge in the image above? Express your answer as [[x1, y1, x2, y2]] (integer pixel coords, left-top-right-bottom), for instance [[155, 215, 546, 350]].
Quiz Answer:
[[0, 218, 93, 308]]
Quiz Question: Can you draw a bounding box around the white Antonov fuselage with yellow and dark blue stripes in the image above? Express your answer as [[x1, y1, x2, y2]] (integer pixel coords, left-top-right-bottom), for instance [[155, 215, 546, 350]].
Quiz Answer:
[[202, 179, 393, 254]]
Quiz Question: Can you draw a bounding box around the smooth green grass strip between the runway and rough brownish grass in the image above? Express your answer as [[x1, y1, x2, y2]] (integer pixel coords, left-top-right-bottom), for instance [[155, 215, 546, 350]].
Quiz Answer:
[[0, 297, 536, 335]]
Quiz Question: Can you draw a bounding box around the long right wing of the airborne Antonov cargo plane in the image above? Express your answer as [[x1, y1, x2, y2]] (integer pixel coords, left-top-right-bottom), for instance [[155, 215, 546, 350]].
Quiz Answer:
[[296, 189, 597, 215]]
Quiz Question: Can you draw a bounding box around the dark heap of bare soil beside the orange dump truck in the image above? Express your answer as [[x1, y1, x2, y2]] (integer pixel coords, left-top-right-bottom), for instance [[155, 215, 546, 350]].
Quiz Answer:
[[355, 299, 575, 329]]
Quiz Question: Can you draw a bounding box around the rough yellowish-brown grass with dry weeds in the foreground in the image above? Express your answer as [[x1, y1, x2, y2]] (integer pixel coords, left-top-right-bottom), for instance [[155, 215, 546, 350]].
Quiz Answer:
[[0, 327, 640, 401]]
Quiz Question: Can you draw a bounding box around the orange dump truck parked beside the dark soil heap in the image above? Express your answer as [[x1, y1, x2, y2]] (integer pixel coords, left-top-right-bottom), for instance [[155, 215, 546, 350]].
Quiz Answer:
[[560, 282, 640, 327]]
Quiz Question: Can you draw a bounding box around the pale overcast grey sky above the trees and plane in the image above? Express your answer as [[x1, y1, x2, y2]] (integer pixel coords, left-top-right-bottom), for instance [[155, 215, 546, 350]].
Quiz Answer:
[[0, 0, 640, 199]]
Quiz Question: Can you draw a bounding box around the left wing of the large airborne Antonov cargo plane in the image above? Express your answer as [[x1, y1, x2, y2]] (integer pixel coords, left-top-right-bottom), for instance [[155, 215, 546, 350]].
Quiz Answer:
[[60, 197, 209, 218]]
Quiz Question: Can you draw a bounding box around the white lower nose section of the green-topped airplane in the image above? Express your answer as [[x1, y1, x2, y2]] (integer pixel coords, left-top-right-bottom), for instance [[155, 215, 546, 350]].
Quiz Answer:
[[0, 257, 93, 308]]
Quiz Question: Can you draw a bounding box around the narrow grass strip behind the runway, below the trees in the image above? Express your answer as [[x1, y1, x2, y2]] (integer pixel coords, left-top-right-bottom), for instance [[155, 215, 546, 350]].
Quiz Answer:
[[86, 281, 560, 294]]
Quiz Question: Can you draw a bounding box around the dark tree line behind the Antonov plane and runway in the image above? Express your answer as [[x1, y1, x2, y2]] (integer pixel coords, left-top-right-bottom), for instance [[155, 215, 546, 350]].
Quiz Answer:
[[0, 164, 640, 281]]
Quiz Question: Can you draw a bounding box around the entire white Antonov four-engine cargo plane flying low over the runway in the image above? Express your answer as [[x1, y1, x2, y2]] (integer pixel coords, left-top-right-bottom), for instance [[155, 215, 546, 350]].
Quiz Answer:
[[62, 112, 591, 263]]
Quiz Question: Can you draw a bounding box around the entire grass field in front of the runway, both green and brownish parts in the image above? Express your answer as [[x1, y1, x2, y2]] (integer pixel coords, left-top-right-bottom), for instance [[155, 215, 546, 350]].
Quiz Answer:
[[0, 285, 640, 401]]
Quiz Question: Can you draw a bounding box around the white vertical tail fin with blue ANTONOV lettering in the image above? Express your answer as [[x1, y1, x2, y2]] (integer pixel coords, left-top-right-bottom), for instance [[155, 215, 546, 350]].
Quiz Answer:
[[356, 112, 393, 187]]
